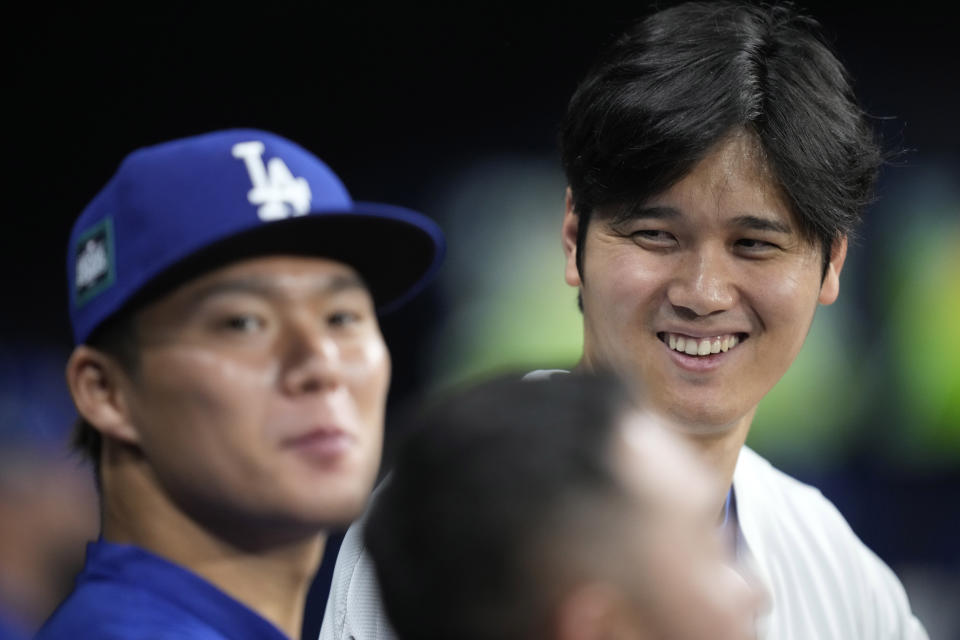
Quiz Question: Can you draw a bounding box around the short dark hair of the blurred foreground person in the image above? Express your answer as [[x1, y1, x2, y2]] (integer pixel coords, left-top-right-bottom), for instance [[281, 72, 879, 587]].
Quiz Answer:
[[364, 374, 630, 640]]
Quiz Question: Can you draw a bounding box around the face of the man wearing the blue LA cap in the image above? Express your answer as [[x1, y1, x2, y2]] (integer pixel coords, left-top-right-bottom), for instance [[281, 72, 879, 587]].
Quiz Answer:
[[115, 257, 390, 535]]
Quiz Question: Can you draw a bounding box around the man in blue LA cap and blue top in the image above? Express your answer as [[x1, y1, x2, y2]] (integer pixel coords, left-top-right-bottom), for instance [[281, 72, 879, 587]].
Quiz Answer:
[[38, 130, 444, 640]]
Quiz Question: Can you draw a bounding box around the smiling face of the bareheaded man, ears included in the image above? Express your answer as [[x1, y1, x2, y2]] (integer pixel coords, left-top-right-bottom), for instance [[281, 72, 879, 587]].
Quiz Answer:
[[563, 134, 846, 433]]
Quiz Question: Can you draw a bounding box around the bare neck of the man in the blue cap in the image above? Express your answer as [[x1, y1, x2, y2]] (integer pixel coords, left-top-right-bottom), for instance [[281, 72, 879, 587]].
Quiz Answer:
[[103, 448, 326, 638]]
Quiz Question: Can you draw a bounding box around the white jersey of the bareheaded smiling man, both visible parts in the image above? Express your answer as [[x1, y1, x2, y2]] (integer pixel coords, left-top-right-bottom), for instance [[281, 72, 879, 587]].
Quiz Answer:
[[320, 372, 928, 640]]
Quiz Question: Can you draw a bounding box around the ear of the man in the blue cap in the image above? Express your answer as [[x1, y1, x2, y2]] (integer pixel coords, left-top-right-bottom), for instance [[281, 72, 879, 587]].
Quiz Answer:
[[66, 344, 140, 444]]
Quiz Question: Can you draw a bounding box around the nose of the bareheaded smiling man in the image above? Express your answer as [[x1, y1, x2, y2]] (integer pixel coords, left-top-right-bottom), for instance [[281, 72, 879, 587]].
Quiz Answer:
[[667, 248, 736, 319]]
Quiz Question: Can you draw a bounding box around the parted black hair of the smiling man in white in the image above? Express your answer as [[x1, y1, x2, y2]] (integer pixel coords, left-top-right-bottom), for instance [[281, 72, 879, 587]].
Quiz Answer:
[[560, 1, 883, 278]]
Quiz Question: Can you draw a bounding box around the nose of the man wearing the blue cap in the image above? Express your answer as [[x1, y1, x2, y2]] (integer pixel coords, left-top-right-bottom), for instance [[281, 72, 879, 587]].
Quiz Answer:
[[281, 321, 343, 395]]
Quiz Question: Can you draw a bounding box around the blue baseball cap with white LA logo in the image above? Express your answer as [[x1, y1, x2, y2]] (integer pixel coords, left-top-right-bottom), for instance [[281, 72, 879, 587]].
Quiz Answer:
[[67, 129, 445, 344]]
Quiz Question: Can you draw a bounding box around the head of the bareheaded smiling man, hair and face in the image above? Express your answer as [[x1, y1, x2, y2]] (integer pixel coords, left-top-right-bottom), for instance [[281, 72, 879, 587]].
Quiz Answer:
[[561, 2, 882, 434]]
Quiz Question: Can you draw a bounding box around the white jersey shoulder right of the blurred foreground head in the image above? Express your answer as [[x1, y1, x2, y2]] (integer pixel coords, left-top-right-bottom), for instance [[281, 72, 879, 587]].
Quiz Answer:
[[733, 447, 927, 640]]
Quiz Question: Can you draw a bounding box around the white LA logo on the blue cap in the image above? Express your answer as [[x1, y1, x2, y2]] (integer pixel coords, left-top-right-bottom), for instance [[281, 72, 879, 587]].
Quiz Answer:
[[233, 140, 312, 222]]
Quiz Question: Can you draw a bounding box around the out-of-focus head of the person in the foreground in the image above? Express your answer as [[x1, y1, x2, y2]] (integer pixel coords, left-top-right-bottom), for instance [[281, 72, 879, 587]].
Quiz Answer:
[[364, 375, 758, 640]]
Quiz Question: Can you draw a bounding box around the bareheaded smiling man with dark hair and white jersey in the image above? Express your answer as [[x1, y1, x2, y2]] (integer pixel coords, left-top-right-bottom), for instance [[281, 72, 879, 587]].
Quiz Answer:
[[321, 2, 926, 640]]
